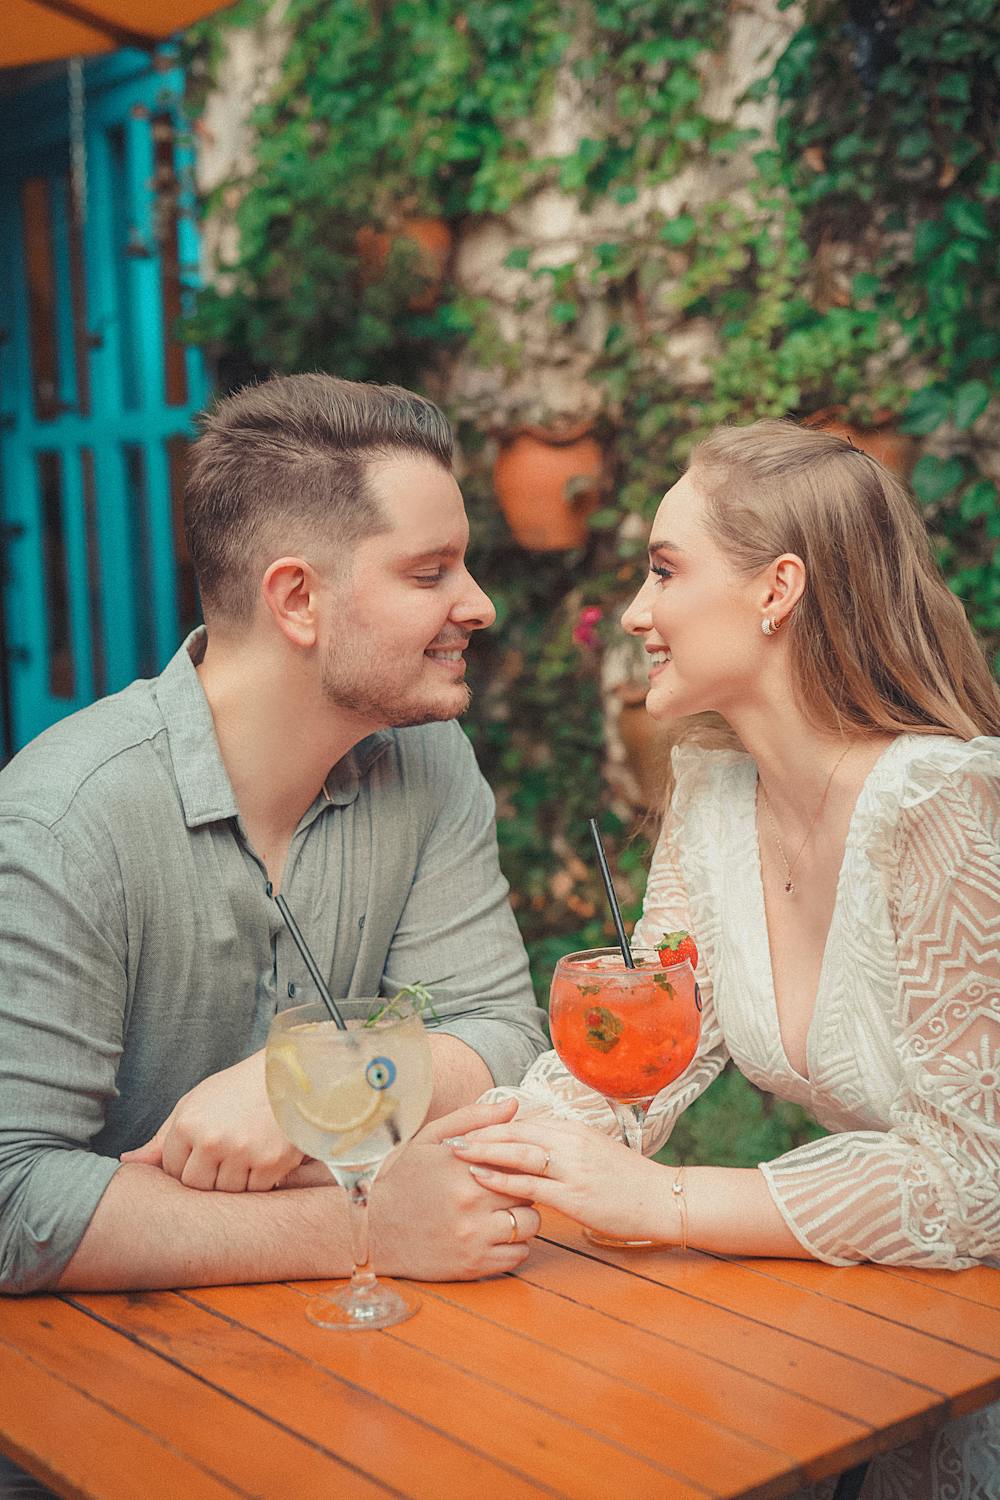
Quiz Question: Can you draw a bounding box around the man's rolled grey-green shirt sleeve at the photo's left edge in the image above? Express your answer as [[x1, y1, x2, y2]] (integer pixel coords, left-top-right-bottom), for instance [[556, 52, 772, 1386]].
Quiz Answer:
[[0, 816, 126, 1293]]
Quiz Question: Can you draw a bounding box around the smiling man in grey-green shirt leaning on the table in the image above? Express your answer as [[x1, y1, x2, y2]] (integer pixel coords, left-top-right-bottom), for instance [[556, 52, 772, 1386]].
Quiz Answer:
[[0, 375, 544, 1292]]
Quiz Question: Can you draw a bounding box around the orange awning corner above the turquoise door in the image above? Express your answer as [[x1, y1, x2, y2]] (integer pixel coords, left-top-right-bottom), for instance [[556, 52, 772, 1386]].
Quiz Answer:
[[0, 0, 239, 68]]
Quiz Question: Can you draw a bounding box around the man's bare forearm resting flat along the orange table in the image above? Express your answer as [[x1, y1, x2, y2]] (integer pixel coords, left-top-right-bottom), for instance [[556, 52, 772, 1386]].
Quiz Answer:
[[58, 1166, 351, 1292]]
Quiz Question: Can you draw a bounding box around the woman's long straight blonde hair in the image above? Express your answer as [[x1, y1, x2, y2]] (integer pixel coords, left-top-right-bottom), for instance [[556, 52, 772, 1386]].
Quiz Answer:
[[690, 422, 1000, 740]]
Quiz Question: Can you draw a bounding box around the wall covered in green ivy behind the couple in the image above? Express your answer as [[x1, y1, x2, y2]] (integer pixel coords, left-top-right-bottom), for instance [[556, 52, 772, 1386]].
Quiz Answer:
[[183, 0, 1000, 1161]]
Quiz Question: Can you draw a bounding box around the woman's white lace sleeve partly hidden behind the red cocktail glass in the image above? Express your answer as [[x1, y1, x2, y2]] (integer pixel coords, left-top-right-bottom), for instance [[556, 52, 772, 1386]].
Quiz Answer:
[[483, 822, 727, 1154]]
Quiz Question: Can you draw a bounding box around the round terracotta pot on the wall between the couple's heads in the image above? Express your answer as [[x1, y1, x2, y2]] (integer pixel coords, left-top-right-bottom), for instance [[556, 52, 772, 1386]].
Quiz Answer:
[[493, 423, 604, 552]]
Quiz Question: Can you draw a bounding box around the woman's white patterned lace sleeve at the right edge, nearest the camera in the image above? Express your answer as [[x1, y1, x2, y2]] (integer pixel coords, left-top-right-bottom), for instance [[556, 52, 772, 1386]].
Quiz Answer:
[[760, 762, 1000, 1269]]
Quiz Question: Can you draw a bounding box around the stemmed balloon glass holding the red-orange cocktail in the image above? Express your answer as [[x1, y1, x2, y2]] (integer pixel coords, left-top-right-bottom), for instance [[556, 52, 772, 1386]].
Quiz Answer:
[[549, 948, 702, 1245]]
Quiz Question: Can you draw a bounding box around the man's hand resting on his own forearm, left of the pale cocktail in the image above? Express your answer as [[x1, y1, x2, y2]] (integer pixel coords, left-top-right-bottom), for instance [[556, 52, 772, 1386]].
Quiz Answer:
[[121, 1052, 306, 1193]]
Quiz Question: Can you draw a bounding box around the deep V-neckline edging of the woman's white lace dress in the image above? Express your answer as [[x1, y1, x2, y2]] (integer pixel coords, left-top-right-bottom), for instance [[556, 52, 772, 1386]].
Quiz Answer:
[[742, 735, 903, 1089]]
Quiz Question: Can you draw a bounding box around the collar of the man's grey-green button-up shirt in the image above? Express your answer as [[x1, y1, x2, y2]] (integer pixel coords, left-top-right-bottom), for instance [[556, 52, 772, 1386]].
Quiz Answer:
[[154, 626, 391, 828]]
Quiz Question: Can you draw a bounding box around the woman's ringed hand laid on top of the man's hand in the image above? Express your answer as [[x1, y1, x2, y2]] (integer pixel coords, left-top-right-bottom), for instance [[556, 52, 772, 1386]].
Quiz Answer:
[[444, 1119, 681, 1244]]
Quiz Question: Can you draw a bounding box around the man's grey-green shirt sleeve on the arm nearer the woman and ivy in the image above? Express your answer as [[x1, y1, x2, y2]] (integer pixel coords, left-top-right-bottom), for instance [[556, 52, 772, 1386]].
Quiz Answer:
[[384, 725, 546, 1083]]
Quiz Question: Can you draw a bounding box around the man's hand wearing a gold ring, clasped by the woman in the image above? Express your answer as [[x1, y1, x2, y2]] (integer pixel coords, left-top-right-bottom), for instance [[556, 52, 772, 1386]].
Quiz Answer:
[[370, 1100, 538, 1281]]
